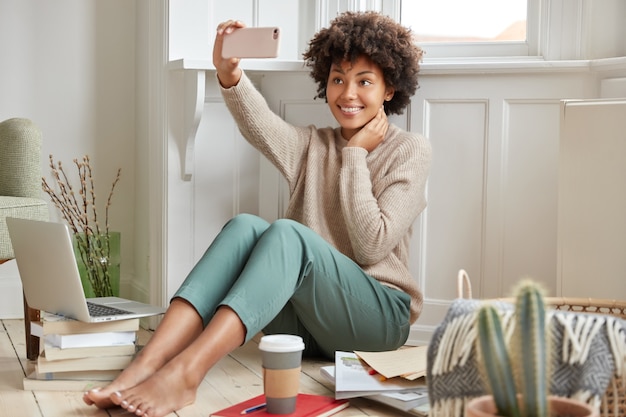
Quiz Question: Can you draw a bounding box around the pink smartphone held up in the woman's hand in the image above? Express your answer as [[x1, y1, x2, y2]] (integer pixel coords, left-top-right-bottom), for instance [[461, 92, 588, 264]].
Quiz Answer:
[[222, 27, 280, 58]]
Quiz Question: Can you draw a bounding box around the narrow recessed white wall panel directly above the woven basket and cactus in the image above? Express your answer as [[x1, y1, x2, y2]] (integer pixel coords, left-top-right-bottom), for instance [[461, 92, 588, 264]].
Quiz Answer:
[[500, 100, 559, 296]]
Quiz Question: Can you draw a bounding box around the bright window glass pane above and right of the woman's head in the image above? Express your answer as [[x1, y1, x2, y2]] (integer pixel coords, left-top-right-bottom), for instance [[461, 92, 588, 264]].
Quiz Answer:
[[400, 0, 527, 43]]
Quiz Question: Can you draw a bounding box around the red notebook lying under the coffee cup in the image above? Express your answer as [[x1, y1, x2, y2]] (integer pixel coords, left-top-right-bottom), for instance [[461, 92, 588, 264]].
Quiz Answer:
[[211, 394, 350, 417]]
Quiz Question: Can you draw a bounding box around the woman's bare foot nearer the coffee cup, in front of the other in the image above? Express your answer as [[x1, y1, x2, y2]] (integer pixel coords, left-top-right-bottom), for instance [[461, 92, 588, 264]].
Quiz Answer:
[[111, 361, 195, 417]]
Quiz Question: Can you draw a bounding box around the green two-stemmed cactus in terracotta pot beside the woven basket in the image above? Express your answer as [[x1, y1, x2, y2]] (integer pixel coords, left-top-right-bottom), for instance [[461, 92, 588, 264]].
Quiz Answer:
[[465, 280, 597, 417]]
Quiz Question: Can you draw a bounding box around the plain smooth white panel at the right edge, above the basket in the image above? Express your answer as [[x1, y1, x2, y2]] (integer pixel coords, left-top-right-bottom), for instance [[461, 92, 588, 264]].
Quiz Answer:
[[558, 100, 626, 300]]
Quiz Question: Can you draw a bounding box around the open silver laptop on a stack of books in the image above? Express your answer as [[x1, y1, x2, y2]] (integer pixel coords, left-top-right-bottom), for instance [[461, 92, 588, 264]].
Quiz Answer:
[[6, 217, 165, 322]]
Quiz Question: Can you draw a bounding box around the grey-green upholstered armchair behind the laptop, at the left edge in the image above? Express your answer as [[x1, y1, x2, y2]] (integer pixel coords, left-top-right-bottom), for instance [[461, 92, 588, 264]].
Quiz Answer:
[[0, 118, 48, 359]]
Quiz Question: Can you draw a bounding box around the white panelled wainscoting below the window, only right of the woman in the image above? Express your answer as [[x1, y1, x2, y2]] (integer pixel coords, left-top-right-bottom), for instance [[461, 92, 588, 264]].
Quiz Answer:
[[394, 73, 576, 343]]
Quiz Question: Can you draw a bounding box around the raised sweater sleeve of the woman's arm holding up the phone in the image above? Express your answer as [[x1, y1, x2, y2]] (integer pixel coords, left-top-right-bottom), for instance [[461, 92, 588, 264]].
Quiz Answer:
[[220, 72, 313, 186]]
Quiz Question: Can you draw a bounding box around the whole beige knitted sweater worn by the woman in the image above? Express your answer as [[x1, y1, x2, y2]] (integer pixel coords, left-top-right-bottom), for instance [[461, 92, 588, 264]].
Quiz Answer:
[[222, 73, 431, 323]]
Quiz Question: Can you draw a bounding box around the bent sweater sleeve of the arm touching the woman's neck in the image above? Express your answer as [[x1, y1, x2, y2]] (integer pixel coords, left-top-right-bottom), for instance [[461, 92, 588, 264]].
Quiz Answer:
[[340, 135, 431, 265]]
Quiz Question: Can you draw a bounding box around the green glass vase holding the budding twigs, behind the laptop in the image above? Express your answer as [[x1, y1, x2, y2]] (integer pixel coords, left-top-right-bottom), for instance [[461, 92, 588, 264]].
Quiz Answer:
[[73, 232, 121, 298]]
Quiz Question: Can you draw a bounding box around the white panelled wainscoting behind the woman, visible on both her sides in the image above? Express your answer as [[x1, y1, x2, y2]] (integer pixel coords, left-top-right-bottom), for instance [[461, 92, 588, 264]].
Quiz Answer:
[[168, 63, 620, 343]]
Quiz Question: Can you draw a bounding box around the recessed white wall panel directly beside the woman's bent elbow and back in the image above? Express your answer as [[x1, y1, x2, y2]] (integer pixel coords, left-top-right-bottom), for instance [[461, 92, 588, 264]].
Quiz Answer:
[[420, 100, 488, 300]]
